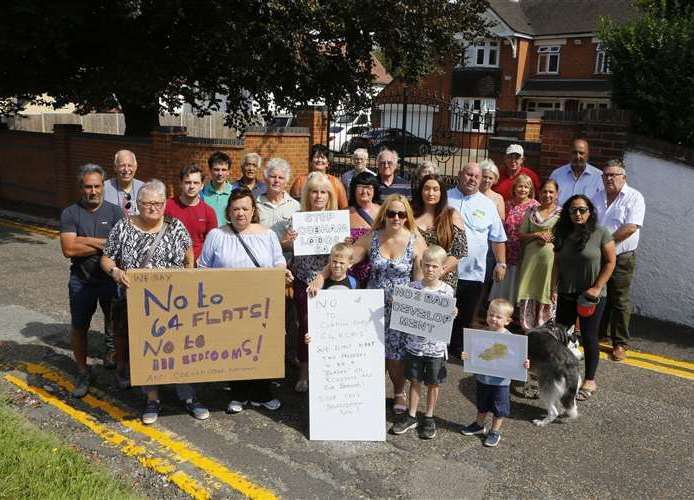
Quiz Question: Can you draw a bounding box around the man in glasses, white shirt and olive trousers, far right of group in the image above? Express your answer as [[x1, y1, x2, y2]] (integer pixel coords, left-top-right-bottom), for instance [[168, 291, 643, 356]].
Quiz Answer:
[[593, 160, 646, 361]]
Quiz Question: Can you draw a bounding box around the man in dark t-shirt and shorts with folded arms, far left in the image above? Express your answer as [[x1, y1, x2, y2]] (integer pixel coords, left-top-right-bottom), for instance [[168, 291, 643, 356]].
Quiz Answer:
[[60, 164, 123, 398]]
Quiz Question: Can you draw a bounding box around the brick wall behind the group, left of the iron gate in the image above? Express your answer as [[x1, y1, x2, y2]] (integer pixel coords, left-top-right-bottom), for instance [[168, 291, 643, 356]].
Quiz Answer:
[[0, 125, 310, 214]]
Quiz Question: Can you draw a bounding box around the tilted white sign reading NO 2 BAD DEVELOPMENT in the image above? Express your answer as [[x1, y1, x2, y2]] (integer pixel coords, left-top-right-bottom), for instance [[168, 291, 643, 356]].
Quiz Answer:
[[390, 286, 455, 343]]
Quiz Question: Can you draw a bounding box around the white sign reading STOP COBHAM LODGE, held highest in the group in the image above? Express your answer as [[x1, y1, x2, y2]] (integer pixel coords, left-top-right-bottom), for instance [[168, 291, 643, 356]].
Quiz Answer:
[[292, 210, 349, 255]]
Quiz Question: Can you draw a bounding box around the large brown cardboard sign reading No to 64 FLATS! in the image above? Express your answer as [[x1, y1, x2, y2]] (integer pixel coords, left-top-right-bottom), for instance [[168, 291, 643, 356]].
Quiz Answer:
[[127, 269, 284, 385]]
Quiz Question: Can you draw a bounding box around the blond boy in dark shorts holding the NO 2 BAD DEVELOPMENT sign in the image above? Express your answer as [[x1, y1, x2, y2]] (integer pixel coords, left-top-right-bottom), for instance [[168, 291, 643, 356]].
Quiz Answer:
[[391, 245, 455, 439]]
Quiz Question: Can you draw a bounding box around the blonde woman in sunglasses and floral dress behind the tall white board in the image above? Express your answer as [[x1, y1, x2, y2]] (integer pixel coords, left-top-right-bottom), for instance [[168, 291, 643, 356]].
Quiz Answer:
[[353, 194, 427, 414]]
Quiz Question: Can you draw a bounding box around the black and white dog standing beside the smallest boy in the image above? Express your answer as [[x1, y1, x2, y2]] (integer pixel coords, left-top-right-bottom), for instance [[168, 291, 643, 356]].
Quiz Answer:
[[528, 321, 581, 426]]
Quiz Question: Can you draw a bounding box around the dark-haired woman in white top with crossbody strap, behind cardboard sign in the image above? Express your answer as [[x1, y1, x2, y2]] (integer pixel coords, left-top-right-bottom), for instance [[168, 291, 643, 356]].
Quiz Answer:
[[198, 188, 291, 413]]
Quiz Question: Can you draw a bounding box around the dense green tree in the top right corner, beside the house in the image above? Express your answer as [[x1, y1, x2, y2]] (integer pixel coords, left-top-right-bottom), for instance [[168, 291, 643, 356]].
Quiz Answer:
[[600, 0, 694, 146]]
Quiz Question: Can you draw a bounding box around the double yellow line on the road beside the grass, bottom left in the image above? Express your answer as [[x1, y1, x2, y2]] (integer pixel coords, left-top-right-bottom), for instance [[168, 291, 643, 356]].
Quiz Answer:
[[5, 363, 277, 500]]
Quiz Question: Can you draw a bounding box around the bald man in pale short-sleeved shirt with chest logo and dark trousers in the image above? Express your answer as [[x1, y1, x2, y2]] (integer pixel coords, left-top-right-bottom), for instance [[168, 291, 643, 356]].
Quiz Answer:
[[448, 162, 506, 357]]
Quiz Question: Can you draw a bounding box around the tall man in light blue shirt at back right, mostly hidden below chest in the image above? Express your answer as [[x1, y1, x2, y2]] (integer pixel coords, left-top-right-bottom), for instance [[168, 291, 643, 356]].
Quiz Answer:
[[549, 139, 603, 206]]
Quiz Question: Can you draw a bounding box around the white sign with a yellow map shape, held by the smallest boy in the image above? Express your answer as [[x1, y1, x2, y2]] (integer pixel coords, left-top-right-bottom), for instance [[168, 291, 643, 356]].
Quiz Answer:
[[463, 328, 528, 382]]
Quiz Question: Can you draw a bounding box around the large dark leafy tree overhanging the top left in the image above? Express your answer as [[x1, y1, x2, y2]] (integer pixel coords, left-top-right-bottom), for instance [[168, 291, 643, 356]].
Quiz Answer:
[[0, 0, 486, 135]]
